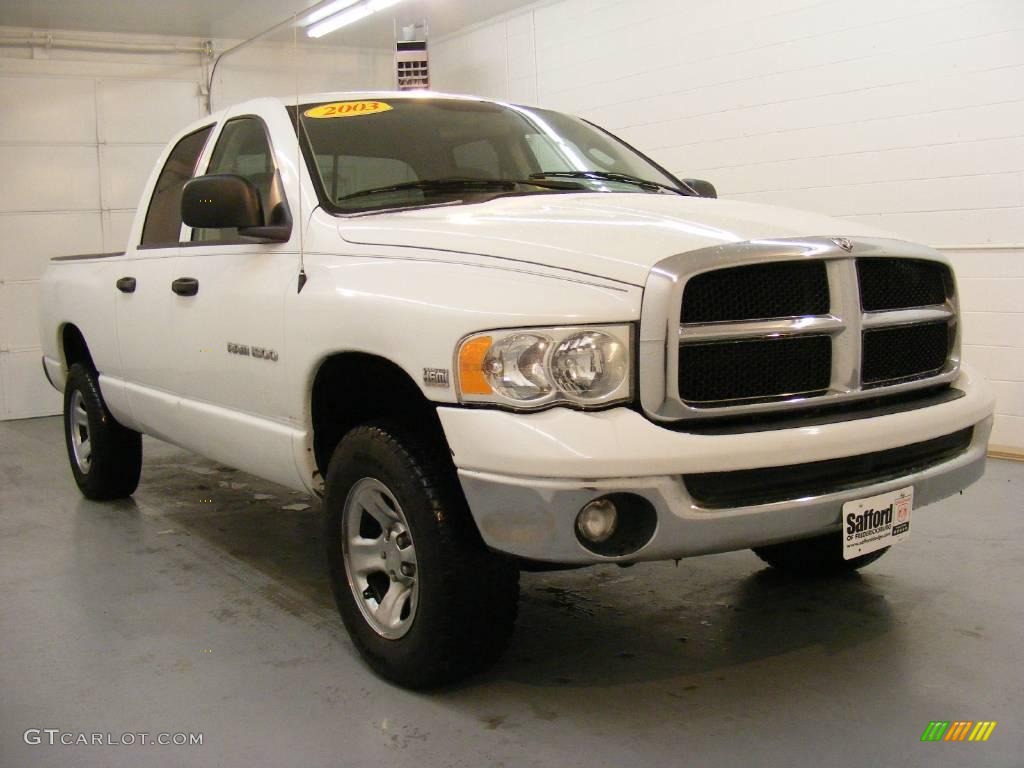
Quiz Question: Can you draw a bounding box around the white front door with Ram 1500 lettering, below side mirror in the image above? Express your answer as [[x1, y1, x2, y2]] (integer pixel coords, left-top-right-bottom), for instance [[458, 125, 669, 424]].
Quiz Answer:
[[170, 115, 300, 484]]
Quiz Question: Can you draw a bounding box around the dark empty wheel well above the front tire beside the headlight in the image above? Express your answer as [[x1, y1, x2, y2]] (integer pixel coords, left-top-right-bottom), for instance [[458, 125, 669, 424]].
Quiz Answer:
[[310, 352, 449, 476]]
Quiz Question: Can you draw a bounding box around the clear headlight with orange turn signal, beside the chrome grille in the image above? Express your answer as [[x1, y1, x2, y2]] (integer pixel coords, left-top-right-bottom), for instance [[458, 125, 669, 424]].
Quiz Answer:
[[457, 326, 632, 409]]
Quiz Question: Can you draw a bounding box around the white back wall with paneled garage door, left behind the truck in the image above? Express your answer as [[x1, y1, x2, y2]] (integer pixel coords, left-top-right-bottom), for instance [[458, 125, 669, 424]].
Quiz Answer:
[[0, 28, 392, 419]]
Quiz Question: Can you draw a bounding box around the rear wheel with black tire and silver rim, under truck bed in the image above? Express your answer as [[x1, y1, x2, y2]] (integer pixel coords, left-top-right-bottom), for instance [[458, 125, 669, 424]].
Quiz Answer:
[[63, 364, 142, 501]]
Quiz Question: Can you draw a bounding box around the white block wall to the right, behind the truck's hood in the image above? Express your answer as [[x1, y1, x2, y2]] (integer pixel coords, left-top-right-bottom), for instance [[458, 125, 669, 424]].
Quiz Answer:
[[431, 0, 1024, 450]]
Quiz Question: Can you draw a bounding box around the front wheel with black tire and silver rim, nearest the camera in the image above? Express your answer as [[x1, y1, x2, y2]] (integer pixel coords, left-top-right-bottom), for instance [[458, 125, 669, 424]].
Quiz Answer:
[[324, 424, 519, 688]]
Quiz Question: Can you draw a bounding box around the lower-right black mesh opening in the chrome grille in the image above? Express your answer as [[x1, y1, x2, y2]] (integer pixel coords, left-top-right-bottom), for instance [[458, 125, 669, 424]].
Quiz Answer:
[[860, 323, 952, 387]]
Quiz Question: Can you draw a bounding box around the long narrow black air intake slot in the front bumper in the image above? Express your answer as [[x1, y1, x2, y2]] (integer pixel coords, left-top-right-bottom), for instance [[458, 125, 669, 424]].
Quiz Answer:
[[683, 427, 974, 509]]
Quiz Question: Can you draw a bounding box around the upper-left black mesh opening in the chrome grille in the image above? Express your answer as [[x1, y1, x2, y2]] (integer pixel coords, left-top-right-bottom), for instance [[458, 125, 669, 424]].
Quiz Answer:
[[680, 261, 828, 323]]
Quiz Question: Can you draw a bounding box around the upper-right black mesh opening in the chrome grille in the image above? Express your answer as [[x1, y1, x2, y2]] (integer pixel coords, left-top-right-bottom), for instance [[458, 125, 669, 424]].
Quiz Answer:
[[857, 258, 951, 312]]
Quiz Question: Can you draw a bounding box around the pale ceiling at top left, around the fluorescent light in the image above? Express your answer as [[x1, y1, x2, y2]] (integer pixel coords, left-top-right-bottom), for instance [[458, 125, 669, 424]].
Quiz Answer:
[[0, 0, 536, 47]]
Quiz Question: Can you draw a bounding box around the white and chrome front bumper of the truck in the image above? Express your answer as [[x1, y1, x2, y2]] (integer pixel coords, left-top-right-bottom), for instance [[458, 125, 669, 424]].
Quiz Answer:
[[438, 369, 993, 564]]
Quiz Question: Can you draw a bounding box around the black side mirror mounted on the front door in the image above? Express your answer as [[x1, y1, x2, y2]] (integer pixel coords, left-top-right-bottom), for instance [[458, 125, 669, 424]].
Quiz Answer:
[[181, 173, 292, 243]]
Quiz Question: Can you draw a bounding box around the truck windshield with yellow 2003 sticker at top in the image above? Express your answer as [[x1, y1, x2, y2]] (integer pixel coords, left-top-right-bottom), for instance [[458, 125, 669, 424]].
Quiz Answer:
[[299, 97, 686, 213]]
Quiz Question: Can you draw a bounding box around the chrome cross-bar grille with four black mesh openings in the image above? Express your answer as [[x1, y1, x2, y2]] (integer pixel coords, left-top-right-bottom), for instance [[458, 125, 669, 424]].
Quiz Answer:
[[640, 238, 959, 420]]
